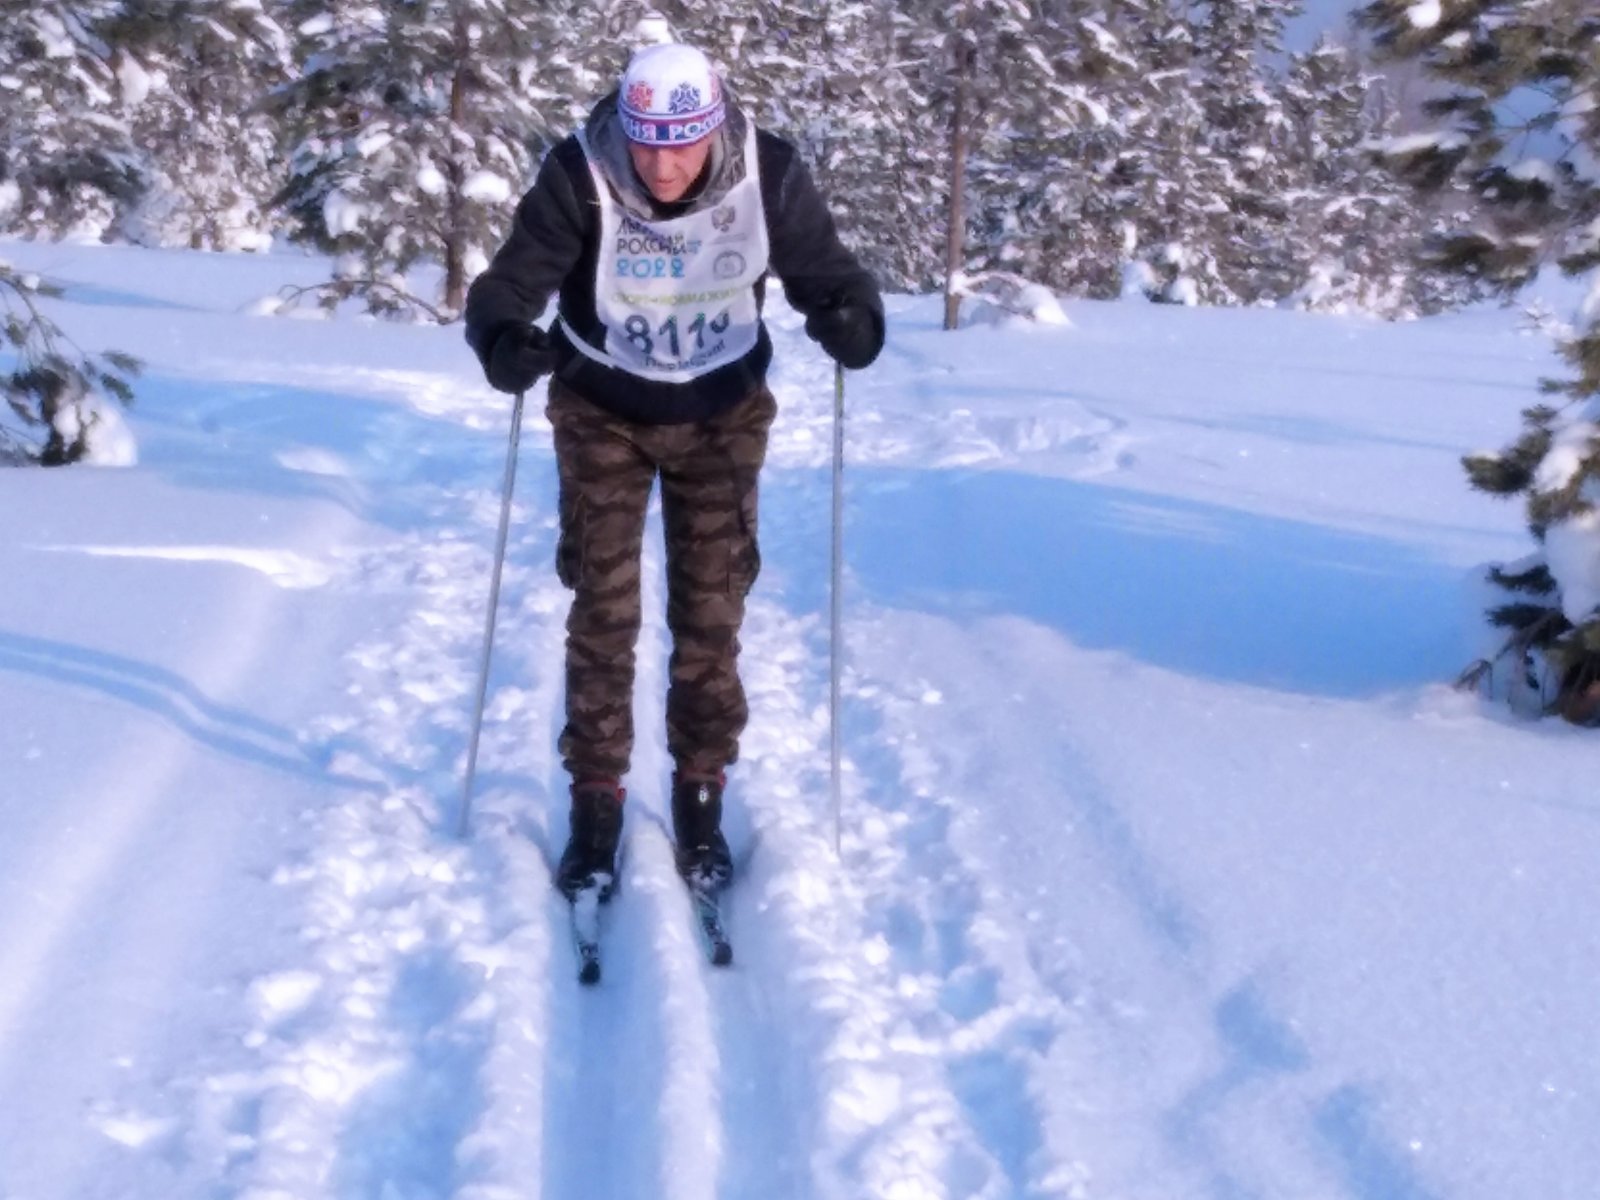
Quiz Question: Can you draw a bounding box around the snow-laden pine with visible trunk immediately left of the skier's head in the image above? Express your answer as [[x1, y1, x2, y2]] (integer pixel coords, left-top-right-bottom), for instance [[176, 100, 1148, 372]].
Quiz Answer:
[[272, 0, 608, 318]]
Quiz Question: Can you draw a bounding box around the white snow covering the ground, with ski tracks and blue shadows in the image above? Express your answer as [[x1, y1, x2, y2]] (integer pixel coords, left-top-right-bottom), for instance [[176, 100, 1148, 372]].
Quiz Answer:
[[0, 242, 1600, 1200]]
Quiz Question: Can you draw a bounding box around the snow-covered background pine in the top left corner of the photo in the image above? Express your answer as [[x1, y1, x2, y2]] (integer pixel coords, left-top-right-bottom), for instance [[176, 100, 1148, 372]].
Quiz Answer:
[[0, 0, 146, 238]]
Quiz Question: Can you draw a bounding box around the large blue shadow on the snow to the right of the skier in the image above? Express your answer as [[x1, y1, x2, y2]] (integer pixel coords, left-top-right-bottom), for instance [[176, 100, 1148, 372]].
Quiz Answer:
[[763, 469, 1467, 698]]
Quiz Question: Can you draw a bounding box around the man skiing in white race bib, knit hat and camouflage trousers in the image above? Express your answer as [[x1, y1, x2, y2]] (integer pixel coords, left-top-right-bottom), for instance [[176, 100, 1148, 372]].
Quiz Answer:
[[466, 45, 885, 899]]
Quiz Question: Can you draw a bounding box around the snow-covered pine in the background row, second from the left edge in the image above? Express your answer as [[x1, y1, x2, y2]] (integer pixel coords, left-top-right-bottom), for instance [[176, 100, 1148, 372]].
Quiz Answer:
[[104, 0, 290, 250]]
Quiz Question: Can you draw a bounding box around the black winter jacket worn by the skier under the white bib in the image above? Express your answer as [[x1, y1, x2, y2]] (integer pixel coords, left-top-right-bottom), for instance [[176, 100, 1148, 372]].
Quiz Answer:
[[466, 98, 883, 424]]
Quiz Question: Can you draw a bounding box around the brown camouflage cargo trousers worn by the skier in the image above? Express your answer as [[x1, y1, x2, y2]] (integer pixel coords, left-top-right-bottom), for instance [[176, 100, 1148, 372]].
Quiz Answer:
[[546, 381, 778, 779]]
